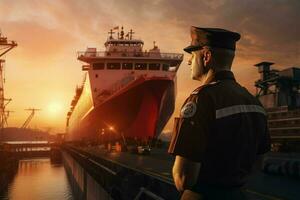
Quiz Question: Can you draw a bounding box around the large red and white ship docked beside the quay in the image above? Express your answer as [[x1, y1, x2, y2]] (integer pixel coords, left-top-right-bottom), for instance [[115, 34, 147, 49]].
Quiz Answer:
[[66, 27, 183, 142]]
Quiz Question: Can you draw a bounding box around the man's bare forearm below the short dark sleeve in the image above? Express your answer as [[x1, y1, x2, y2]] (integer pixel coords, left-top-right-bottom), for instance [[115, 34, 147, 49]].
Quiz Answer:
[[172, 156, 201, 192]]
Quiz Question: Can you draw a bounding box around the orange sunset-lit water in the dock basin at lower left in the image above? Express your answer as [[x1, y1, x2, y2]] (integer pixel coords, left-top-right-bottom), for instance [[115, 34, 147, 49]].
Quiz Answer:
[[3, 158, 73, 200]]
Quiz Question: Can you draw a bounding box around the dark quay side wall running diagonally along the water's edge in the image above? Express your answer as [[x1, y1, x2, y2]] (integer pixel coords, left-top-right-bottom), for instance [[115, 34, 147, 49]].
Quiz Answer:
[[62, 147, 180, 200]]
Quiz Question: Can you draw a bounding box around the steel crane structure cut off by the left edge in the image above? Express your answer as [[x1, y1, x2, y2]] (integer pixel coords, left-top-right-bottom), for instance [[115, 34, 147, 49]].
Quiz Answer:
[[0, 31, 17, 138]]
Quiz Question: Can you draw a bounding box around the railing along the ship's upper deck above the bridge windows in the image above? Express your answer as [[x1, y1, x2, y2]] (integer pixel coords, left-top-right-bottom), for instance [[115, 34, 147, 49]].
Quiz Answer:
[[77, 51, 183, 60]]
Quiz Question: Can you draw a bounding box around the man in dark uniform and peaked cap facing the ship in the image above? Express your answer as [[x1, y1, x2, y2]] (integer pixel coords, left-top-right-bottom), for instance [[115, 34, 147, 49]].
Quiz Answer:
[[169, 27, 270, 200]]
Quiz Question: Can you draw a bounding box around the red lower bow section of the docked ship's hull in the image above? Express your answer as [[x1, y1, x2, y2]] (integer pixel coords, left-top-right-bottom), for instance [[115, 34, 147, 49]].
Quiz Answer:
[[72, 78, 176, 141]]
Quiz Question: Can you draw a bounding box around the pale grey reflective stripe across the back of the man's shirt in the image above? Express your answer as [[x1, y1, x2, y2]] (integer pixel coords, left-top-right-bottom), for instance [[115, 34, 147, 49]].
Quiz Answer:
[[216, 105, 266, 119]]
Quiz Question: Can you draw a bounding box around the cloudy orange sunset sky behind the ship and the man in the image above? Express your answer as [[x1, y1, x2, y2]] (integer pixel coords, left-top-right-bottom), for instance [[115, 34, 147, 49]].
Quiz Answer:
[[0, 0, 300, 132]]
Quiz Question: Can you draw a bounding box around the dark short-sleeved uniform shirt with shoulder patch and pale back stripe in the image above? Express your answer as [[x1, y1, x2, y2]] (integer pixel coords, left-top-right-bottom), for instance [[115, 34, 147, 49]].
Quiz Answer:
[[169, 71, 270, 187]]
